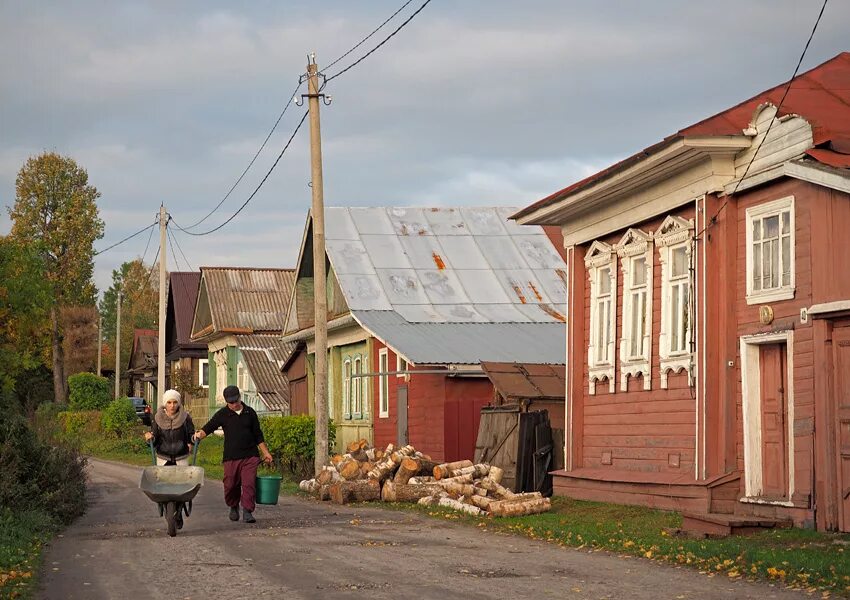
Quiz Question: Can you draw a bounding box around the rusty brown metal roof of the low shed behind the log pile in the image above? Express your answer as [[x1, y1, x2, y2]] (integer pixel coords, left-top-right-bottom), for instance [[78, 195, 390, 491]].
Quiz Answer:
[[481, 362, 567, 400]]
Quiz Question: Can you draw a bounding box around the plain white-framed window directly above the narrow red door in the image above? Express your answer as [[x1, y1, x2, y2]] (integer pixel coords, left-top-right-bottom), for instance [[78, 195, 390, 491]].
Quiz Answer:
[[747, 196, 795, 304]]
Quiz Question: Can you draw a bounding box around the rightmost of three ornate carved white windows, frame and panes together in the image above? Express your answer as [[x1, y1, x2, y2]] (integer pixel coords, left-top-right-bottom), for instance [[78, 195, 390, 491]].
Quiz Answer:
[[655, 216, 694, 388]]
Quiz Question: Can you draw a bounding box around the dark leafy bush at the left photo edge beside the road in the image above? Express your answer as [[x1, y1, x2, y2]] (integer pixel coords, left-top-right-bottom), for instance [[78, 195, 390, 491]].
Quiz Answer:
[[0, 415, 85, 523]]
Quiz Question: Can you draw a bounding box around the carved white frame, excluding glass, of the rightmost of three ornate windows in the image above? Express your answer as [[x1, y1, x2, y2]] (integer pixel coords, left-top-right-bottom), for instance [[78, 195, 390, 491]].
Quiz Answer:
[[654, 215, 694, 389]]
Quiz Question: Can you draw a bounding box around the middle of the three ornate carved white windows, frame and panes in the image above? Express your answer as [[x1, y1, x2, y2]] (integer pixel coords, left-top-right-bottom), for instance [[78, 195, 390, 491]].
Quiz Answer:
[[616, 229, 653, 391]]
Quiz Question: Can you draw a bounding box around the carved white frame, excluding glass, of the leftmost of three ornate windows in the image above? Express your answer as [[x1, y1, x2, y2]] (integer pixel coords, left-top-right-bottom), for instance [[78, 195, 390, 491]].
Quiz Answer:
[[584, 240, 617, 396]]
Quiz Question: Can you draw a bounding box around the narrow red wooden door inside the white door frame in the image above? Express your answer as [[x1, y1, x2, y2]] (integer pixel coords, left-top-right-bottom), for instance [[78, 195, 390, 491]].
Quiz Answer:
[[759, 344, 789, 498]]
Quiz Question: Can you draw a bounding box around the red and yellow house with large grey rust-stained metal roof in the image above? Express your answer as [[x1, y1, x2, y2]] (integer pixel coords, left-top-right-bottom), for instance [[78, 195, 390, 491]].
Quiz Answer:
[[284, 207, 565, 460]]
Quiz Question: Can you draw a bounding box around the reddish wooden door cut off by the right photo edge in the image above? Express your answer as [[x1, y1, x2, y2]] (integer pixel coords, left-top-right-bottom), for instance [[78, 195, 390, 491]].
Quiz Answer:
[[832, 327, 850, 531]]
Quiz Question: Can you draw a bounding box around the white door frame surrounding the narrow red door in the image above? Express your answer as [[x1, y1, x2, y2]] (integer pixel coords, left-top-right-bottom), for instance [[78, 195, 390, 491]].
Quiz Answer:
[[739, 330, 794, 506]]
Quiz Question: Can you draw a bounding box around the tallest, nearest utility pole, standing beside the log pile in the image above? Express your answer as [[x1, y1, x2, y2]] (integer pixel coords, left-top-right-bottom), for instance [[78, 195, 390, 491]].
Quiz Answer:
[[307, 53, 328, 473]]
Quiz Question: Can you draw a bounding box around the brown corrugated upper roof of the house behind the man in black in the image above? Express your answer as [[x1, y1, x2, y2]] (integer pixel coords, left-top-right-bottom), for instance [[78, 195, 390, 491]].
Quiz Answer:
[[201, 267, 295, 332]]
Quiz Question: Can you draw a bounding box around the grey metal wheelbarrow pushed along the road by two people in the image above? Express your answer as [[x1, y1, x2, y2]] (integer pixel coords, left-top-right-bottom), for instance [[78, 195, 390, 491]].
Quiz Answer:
[[139, 440, 204, 537]]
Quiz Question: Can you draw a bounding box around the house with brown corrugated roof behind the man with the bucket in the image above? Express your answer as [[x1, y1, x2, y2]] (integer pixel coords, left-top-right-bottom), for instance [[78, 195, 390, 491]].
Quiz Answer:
[[191, 267, 295, 414]]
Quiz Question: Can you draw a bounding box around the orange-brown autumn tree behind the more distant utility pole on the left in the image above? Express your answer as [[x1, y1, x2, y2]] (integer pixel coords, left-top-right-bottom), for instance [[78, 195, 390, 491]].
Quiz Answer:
[[100, 258, 159, 384]]
